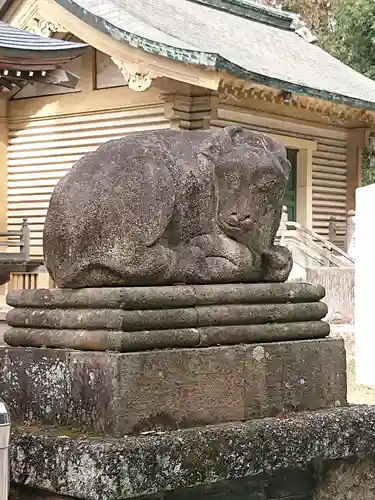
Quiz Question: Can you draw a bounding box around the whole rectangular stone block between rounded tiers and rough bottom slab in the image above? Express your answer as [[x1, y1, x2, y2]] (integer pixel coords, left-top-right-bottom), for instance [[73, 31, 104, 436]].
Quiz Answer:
[[0, 339, 346, 436]]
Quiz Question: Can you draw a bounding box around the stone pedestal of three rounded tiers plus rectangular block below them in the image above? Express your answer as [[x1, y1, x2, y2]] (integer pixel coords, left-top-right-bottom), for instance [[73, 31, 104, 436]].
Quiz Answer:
[[0, 283, 346, 436]]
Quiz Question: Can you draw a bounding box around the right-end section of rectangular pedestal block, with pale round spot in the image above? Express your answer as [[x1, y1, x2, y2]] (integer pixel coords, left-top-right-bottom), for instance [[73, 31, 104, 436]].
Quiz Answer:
[[245, 339, 346, 419]]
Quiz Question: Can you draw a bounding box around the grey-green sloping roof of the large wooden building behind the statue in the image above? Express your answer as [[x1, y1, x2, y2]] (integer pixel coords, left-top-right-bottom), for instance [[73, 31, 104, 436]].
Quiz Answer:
[[56, 0, 375, 109]]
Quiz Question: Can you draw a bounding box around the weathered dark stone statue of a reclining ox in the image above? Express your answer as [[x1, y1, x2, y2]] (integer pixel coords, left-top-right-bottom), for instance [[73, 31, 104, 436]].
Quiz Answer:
[[44, 126, 292, 288]]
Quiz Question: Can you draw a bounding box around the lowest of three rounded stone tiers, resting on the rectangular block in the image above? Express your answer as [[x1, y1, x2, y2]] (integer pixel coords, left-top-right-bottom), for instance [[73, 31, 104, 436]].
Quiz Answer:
[[4, 321, 330, 352]]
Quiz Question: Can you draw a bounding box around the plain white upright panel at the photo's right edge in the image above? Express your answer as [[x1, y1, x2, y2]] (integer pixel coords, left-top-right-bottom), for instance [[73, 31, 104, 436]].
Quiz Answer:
[[355, 184, 375, 386]]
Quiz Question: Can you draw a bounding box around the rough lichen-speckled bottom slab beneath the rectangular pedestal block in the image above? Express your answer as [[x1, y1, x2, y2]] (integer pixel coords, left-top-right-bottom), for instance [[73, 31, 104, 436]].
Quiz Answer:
[[11, 406, 375, 500]]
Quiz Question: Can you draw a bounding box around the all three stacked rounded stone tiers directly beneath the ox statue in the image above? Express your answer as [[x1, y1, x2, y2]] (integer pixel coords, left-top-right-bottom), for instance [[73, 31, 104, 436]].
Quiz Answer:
[[5, 283, 329, 352]]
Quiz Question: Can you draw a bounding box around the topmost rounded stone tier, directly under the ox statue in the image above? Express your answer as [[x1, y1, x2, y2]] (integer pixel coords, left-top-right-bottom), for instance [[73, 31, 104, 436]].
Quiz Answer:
[[6, 282, 325, 310]]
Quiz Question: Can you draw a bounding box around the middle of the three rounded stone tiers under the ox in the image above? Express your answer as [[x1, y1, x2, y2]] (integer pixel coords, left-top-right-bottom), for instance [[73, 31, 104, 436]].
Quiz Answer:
[[6, 302, 327, 332]]
